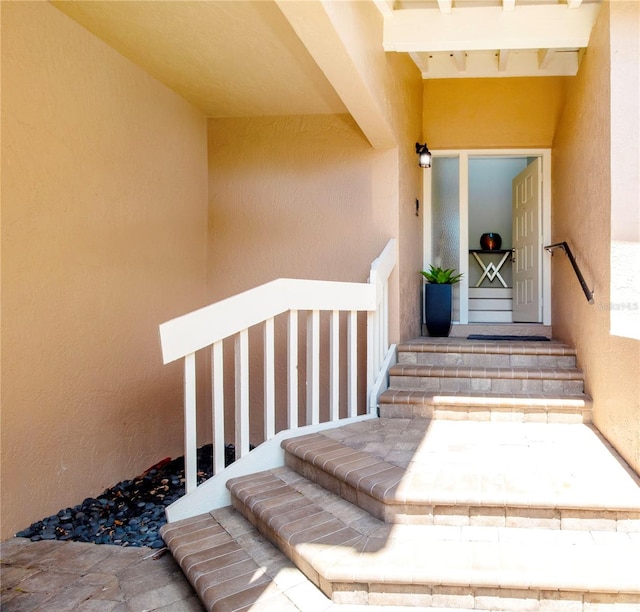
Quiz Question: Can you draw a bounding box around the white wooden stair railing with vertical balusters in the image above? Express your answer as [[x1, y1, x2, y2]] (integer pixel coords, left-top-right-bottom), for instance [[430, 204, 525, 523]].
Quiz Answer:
[[160, 240, 397, 516]]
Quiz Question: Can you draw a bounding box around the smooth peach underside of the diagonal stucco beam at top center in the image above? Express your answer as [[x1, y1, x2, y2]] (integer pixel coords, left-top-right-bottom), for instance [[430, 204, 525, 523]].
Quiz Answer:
[[276, 0, 397, 149]]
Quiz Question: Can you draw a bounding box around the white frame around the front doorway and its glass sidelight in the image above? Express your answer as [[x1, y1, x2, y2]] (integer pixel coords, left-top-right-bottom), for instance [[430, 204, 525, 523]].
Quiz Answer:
[[422, 148, 551, 325]]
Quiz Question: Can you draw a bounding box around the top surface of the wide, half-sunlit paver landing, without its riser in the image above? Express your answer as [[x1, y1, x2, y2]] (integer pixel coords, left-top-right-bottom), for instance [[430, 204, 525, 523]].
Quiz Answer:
[[282, 419, 640, 513]]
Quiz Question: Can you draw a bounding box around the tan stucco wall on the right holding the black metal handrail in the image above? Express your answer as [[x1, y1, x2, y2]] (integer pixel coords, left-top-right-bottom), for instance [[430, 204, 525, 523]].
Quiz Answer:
[[552, 2, 640, 472]]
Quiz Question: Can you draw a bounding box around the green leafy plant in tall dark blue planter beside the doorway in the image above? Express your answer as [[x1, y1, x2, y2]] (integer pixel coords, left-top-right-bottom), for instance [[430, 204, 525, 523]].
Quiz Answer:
[[420, 266, 462, 338]]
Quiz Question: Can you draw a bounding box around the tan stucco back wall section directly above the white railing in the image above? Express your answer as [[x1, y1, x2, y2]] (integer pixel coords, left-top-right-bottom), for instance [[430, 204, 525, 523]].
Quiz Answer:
[[207, 115, 397, 301]]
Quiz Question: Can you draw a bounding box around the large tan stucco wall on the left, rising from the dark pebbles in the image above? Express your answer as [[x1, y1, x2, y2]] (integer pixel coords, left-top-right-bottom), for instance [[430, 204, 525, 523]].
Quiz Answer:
[[0, 2, 207, 538]]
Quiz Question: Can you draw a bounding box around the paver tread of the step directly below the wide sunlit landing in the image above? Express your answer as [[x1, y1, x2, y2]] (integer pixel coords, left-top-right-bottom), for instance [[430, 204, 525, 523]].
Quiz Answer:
[[228, 468, 640, 602]]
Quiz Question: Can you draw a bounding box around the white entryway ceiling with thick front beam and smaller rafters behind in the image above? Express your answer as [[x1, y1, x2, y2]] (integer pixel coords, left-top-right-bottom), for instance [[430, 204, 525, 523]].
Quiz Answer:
[[374, 0, 601, 79]]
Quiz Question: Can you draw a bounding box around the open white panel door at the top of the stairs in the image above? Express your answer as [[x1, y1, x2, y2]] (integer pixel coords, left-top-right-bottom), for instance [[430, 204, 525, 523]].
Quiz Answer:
[[512, 158, 542, 323]]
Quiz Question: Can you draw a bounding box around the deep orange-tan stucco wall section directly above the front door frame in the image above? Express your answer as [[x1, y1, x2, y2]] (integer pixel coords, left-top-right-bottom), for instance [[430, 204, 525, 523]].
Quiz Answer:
[[423, 77, 573, 149]]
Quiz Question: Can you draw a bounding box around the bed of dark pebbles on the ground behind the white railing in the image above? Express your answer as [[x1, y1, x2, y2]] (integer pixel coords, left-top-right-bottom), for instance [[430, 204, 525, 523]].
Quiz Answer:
[[16, 444, 235, 548]]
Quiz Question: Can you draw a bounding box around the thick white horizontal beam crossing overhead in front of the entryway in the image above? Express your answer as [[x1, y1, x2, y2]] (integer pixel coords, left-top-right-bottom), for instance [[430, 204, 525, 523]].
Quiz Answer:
[[384, 3, 600, 52]]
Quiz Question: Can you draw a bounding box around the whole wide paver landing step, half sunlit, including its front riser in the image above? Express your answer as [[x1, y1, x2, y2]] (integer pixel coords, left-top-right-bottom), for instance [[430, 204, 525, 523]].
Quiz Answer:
[[282, 419, 640, 533]]
